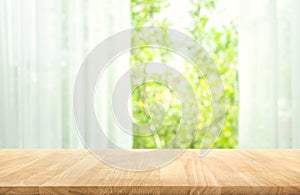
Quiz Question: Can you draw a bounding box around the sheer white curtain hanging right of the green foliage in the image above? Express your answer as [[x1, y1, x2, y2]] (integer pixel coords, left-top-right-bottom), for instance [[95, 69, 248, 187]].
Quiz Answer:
[[239, 0, 300, 148]]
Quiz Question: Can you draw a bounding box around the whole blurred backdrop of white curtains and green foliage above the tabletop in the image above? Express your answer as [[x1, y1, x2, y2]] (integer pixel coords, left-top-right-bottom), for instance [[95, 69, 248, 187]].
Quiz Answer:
[[0, 0, 300, 148]]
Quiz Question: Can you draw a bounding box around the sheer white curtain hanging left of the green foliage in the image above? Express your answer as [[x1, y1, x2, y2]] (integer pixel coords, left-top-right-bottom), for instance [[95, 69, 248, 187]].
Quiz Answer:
[[0, 0, 131, 148]]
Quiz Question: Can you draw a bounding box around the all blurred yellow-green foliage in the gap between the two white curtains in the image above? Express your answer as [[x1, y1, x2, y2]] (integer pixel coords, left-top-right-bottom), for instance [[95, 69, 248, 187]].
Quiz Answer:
[[131, 0, 238, 148]]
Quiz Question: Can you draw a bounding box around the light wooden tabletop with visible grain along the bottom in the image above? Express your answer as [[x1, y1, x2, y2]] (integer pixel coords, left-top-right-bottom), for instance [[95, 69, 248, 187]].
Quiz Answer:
[[0, 149, 300, 194]]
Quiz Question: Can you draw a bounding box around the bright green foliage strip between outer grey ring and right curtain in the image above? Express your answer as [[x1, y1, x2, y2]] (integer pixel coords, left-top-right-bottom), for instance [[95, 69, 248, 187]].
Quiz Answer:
[[188, 0, 238, 148]]
